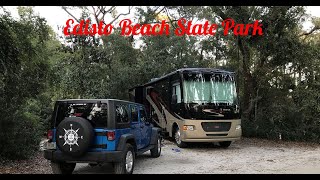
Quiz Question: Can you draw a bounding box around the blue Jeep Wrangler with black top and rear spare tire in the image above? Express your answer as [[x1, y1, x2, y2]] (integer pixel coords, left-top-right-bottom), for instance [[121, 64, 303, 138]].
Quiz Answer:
[[44, 99, 161, 174]]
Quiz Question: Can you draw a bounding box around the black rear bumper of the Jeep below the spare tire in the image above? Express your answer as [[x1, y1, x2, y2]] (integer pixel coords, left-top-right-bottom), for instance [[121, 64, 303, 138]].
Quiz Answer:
[[44, 150, 123, 163]]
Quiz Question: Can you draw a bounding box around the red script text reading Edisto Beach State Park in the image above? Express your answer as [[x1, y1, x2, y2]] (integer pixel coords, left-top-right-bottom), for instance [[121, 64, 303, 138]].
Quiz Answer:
[[63, 18, 263, 36]]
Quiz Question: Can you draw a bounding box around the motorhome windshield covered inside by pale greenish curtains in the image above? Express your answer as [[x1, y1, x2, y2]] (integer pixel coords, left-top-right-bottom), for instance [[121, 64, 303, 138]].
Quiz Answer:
[[183, 73, 237, 104]]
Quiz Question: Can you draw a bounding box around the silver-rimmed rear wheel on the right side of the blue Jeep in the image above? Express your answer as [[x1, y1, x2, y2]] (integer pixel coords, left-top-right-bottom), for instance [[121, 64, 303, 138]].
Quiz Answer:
[[114, 143, 135, 174]]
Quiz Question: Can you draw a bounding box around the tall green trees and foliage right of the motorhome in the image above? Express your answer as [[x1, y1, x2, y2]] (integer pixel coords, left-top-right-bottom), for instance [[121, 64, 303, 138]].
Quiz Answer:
[[189, 6, 320, 141]]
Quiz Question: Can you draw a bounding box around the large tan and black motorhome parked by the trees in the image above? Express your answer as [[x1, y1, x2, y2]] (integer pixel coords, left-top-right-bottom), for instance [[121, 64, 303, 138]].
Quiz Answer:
[[129, 68, 242, 148]]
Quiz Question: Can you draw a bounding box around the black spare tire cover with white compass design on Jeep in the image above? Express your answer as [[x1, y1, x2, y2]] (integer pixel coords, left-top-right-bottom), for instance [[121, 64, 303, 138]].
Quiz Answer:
[[56, 117, 94, 156]]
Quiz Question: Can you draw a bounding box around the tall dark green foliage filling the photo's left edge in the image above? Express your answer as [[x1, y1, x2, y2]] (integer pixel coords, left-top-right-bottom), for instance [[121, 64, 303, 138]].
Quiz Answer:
[[0, 8, 53, 159]]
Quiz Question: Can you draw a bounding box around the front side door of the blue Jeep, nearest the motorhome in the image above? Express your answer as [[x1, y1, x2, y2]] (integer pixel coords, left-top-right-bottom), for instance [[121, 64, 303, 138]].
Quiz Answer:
[[139, 106, 152, 148]]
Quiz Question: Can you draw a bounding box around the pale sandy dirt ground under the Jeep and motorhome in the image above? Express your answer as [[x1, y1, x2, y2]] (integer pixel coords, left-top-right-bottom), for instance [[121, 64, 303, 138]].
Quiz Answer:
[[0, 138, 320, 174]]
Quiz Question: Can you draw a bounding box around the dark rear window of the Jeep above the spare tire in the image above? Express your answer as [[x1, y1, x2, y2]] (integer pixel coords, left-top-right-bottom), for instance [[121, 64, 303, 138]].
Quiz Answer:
[[55, 103, 108, 127]]
